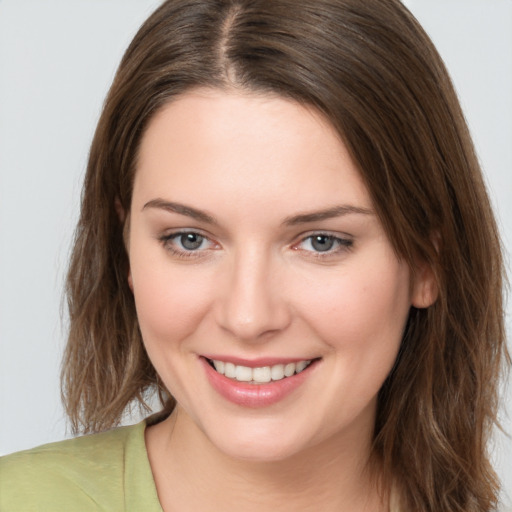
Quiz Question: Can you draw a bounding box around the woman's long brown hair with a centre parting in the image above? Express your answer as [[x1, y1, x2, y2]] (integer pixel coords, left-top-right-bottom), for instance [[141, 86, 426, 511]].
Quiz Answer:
[[62, 0, 510, 512]]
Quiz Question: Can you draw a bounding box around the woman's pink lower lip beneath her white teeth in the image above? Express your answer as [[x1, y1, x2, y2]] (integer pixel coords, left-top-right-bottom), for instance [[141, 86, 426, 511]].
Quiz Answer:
[[200, 357, 317, 408]]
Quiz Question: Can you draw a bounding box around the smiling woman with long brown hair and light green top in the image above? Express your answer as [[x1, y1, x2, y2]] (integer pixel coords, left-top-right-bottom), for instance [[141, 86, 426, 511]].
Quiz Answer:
[[0, 0, 509, 511]]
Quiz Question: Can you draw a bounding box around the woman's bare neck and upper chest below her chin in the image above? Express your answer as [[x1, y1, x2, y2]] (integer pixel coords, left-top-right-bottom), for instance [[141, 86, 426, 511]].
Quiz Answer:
[[146, 407, 388, 512]]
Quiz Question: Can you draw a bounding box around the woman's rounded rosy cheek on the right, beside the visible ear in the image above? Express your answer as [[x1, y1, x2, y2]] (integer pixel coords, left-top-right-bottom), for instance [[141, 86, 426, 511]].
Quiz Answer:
[[294, 254, 410, 358]]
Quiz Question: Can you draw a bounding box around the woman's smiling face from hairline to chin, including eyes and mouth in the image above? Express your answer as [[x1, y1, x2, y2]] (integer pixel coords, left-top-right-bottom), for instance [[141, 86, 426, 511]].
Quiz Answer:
[[128, 90, 432, 460]]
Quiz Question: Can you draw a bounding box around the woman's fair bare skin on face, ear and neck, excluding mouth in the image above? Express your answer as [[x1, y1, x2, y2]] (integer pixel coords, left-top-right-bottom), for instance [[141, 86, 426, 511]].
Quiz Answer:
[[128, 90, 433, 512]]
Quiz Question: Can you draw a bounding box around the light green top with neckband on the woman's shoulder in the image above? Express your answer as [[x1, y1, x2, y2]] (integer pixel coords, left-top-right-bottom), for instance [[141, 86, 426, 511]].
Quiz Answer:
[[0, 422, 162, 512]]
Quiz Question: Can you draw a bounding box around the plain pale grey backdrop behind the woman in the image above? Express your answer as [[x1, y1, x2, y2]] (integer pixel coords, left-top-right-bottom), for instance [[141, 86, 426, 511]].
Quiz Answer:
[[0, 0, 512, 499]]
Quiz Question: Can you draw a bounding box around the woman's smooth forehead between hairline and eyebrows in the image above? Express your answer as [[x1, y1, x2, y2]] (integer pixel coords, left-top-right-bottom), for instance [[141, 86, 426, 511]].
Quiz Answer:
[[134, 89, 371, 216]]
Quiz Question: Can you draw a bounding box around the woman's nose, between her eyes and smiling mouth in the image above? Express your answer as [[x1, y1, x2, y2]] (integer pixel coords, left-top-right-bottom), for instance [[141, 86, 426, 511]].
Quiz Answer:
[[217, 248, 291, 342]]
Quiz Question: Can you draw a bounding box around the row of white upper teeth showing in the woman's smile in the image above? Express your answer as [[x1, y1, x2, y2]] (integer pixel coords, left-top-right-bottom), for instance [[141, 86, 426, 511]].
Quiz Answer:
[[212, 359, 312, 384]]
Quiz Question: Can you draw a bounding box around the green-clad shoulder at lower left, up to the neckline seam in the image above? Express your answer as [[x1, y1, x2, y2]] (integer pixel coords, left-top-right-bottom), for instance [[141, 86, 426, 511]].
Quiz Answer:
[[0, 424, 144, 512]]
